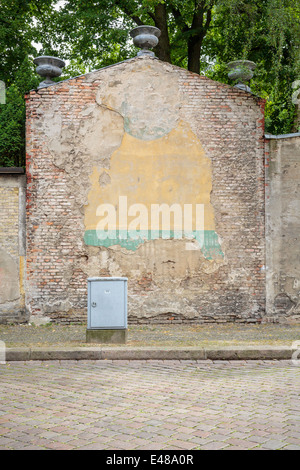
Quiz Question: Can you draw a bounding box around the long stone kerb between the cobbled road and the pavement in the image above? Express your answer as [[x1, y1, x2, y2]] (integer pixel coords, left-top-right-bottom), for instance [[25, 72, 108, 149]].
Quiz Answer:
[[5, 346, 297, 362]]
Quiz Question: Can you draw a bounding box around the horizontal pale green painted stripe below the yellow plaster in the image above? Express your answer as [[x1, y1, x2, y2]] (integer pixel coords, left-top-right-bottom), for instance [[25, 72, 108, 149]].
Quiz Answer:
[[84, 230, 224, 259]]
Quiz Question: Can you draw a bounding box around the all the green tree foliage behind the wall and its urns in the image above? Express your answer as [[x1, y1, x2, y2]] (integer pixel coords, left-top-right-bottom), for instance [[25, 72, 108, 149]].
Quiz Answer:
[[0, 0, 300, 165]]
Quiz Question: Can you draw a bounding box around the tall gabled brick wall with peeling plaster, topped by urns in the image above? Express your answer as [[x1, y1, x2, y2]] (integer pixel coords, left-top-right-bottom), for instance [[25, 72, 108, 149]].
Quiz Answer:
[[26, 58, 265, 323]]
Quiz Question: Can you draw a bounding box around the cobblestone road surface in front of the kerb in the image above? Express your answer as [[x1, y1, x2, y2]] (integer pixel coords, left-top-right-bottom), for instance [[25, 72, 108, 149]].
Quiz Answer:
[[0, 361, 300, 450]]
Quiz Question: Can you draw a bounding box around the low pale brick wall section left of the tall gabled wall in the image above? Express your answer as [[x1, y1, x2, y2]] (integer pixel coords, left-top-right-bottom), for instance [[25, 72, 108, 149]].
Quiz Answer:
[[0, 172, 27, 323]]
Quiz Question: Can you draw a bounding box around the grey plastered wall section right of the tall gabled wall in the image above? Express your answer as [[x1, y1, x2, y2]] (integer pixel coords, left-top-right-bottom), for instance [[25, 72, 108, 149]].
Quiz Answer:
[[266, 134, 300, 322]]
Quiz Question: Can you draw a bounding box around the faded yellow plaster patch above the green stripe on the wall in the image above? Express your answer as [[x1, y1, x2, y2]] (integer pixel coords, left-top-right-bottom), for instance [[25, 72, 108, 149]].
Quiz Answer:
[[85, 122, 215, 230]]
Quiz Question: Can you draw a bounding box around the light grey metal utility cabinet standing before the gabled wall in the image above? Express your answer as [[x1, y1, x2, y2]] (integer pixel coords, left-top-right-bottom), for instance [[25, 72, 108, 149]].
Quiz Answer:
[[88, 278, 127, 329]]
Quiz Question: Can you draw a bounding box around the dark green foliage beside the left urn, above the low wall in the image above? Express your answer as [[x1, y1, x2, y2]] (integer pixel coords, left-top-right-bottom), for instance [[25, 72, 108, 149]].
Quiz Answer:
[[0, 0, 53, 166]]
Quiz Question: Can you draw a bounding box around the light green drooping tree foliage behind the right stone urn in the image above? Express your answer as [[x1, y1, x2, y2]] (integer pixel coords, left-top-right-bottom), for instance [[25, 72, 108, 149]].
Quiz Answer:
[[205, 0, 300, 134]]
